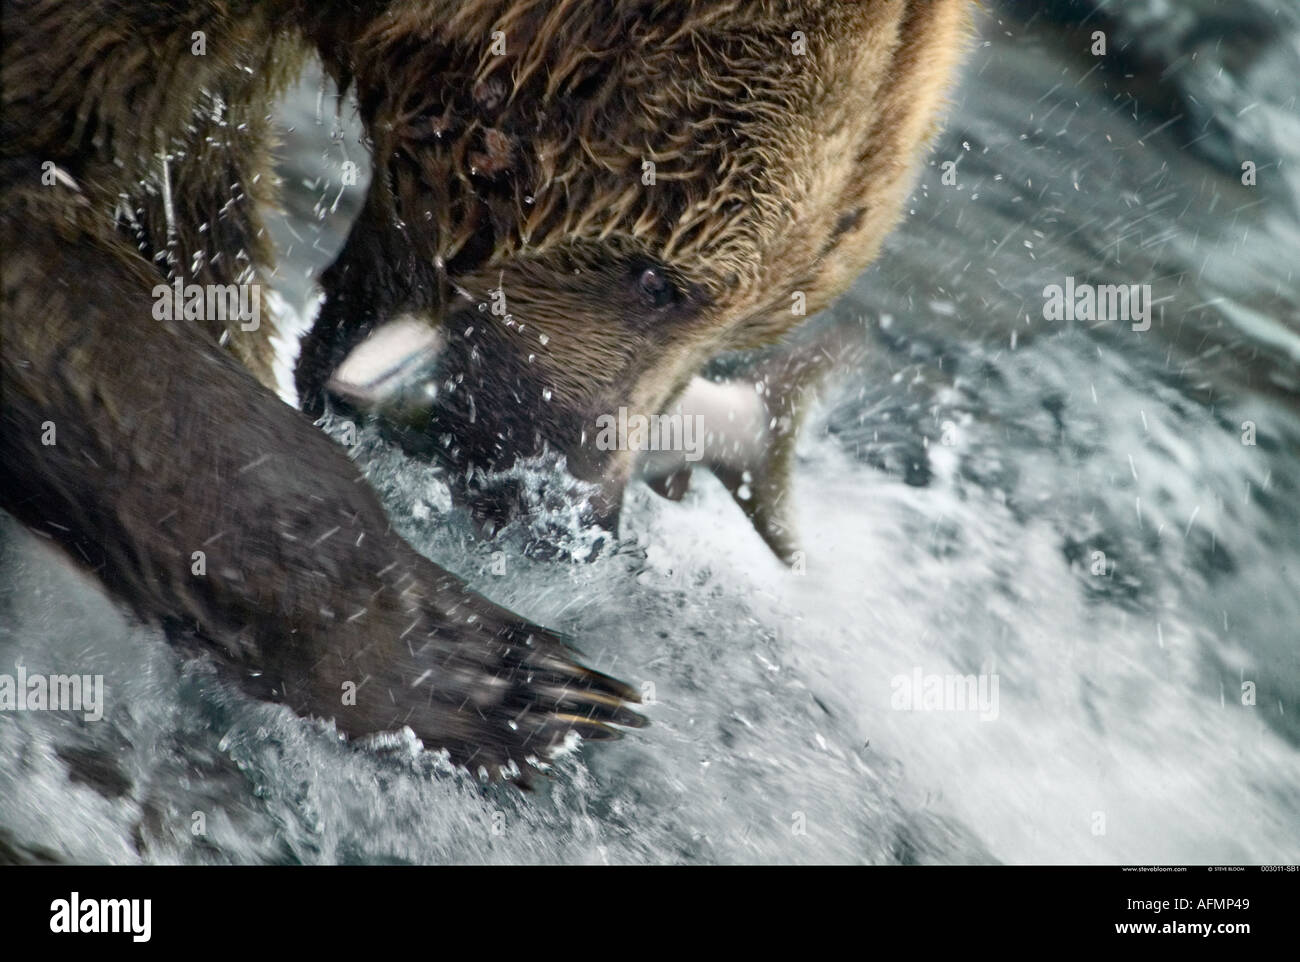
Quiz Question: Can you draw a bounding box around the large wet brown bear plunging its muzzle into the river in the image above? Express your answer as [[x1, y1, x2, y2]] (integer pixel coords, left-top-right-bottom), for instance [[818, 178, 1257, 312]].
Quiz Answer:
[[0, 0, 969, 776]]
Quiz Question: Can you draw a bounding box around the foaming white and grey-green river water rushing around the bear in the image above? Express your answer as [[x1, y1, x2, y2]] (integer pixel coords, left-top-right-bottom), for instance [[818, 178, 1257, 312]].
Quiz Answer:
[[0, 0, 1300, 863]]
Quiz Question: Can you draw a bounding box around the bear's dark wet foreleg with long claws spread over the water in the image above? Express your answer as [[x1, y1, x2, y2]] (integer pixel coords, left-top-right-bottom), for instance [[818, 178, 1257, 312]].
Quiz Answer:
[[0, 204, 640, 774]]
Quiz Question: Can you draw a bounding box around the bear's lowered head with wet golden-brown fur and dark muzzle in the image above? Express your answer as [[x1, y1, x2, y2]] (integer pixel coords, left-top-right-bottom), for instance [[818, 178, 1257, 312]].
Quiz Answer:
[[306, 0, 966, 525]]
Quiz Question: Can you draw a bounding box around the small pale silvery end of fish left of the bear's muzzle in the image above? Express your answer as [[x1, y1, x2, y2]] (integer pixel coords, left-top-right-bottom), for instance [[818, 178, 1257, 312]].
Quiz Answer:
[[325, 316, 443, 413]]
